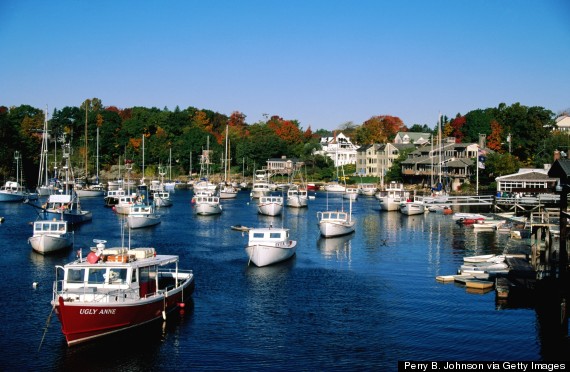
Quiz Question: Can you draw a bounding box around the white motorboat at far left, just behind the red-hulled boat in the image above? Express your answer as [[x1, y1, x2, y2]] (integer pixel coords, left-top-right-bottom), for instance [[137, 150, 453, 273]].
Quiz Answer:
[[28, 220, 73, 254]]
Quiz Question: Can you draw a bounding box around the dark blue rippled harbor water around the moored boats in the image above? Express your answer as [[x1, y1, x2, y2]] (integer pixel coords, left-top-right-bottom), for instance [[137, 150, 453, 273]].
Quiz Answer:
[[0, 190, 560, 371]]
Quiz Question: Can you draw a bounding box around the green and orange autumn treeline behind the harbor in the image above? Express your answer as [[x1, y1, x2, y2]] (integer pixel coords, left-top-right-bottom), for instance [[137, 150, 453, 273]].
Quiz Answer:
[[0, 98, 568, 186]]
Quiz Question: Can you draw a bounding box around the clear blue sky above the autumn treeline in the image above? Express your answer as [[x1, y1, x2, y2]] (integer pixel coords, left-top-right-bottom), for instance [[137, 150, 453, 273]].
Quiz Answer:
[[0, 0, 570, 130]]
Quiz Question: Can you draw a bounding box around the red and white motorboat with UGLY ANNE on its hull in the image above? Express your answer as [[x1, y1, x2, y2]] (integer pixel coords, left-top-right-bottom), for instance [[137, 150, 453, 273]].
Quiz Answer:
[[51, 240, 194, 346]]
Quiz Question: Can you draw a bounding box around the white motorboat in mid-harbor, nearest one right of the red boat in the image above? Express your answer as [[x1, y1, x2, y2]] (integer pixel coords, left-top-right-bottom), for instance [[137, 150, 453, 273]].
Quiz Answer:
[[245, 227, 297, 267]]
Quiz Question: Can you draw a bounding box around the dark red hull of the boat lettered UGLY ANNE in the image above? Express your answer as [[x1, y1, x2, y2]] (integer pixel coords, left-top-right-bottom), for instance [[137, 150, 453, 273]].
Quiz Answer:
[[55, 280, 194, 345]]
